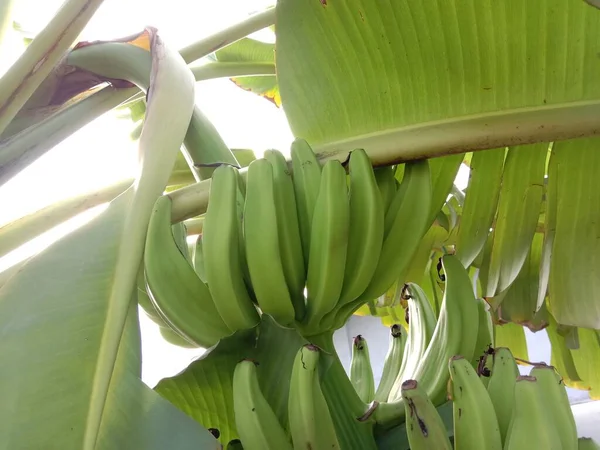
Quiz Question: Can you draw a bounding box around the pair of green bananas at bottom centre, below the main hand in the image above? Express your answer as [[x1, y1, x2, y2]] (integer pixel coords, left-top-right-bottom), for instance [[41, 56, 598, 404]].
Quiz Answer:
[[233, 344, 340, 450]]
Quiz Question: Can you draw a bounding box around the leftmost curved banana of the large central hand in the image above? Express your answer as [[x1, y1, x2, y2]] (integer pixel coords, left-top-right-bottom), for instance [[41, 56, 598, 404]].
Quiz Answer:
[[144, 196, 231, 347]]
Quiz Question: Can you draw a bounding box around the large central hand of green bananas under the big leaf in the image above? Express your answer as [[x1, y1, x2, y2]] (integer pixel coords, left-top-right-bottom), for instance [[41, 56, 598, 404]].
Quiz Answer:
[[140, 139, 432, 347]]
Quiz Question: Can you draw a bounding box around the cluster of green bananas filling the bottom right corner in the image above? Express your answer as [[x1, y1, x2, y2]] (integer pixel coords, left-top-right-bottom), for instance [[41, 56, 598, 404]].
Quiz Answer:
[[394, 348, 580, 450]]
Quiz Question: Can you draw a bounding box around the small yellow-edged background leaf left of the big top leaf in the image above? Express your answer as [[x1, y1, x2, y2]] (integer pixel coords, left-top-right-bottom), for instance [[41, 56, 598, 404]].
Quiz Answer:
[[216, 38, 281, 106]]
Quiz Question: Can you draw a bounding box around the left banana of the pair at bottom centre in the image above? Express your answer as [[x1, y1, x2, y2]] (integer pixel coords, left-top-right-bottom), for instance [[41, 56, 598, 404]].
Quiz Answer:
[[233, 359, 292, 450]]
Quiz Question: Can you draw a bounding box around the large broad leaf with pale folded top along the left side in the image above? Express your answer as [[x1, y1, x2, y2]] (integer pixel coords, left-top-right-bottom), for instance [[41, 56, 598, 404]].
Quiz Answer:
[[0, 29, 209, 450]]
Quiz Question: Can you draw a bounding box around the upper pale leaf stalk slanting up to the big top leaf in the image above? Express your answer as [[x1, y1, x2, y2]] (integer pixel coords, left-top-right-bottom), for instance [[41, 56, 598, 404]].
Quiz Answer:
[[179, 7, 275, 64]]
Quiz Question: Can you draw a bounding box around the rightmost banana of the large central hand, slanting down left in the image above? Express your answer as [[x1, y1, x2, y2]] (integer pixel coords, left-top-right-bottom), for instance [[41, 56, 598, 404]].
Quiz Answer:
[[349, 160, 432, 302]]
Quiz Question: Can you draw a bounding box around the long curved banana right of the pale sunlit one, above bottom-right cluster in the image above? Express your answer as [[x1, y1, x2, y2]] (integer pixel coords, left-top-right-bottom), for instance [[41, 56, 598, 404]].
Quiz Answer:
[[375, 255, 479, 428]]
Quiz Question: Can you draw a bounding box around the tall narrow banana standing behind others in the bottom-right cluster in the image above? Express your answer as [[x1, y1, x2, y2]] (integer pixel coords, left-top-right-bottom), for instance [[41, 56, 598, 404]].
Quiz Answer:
[[487, 347, 519, 443]]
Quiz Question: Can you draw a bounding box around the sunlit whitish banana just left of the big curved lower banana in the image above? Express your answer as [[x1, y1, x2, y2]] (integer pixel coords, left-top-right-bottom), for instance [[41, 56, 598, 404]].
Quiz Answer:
[[386, 283, 437, 400]]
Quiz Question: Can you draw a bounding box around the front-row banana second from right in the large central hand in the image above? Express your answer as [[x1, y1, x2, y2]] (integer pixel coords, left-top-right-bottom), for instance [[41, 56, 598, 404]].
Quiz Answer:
[[338, 149, 384, 305]]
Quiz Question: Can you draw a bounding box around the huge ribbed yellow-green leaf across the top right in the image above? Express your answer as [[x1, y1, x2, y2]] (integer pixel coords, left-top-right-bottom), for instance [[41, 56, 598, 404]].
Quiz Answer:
[[276, 0, 600, 163]]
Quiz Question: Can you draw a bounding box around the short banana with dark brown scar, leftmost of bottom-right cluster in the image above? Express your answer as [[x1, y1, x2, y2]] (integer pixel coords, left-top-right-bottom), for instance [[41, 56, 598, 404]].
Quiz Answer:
[[402, 380, 452, 450]]
